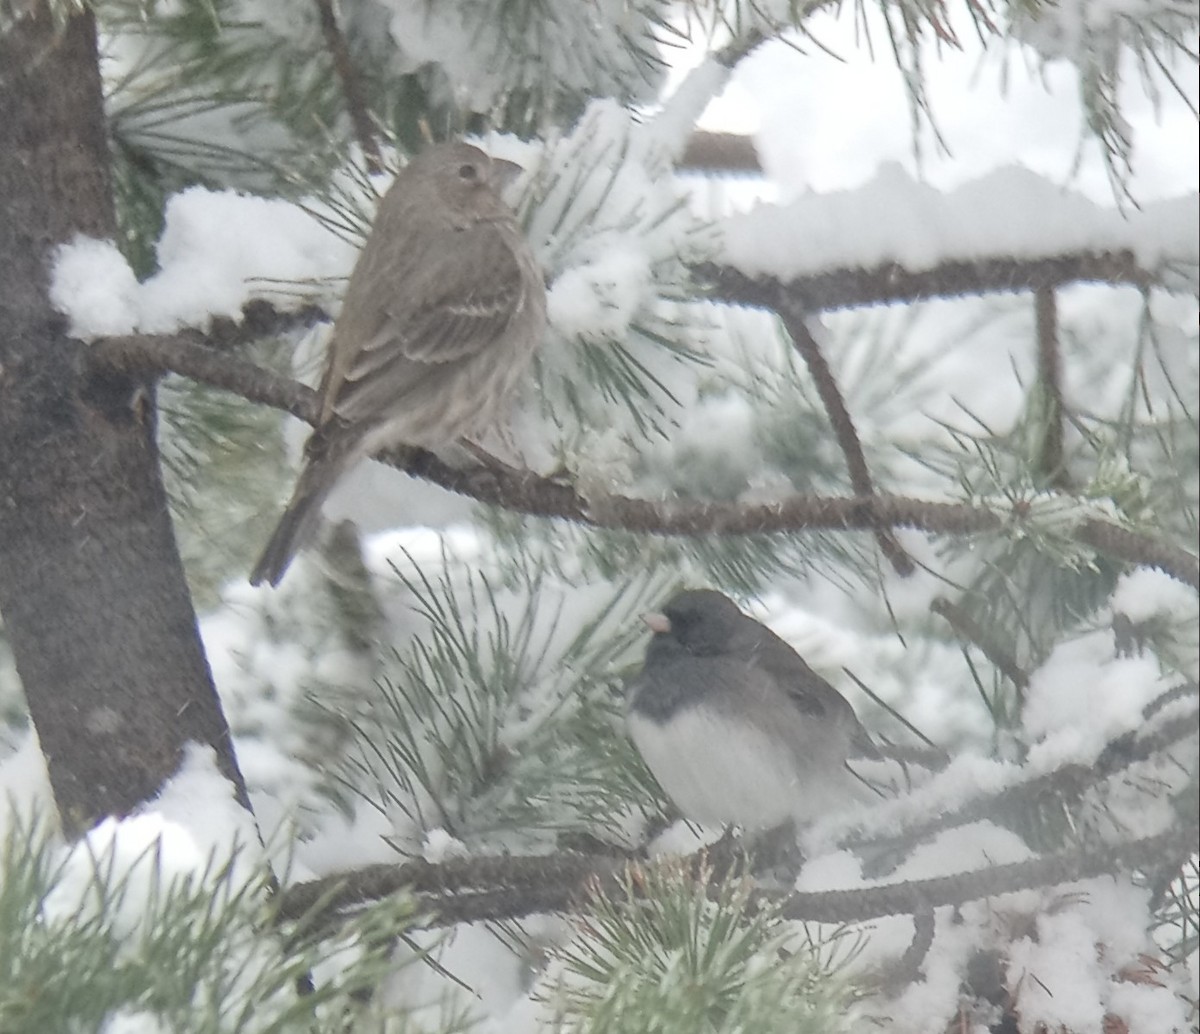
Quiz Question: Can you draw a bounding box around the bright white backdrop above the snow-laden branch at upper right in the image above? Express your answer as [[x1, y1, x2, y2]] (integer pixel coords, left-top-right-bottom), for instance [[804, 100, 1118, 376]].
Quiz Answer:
[[676, 8, 1200, 203]]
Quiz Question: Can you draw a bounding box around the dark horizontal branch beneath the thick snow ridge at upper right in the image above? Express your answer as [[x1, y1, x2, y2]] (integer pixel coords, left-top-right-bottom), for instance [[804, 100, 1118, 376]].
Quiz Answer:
[[694, 245, 1160, 312]]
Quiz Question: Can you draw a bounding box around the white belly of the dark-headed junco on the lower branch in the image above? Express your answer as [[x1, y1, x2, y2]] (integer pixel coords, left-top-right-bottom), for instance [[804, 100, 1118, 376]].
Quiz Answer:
[[629, 708, 829, 829]]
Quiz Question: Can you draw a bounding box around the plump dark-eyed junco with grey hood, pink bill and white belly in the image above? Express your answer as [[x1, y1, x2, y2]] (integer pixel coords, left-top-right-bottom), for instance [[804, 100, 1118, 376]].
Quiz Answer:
[[625, 589, 877, 830]]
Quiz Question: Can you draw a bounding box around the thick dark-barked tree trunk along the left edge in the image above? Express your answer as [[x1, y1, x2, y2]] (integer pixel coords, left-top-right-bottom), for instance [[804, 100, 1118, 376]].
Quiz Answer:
[[0, 5, 246, 835]]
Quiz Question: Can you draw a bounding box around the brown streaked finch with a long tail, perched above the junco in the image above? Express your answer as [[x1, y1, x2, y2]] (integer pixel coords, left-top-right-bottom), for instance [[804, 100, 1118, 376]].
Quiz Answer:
[[250, 142, 546, 585]]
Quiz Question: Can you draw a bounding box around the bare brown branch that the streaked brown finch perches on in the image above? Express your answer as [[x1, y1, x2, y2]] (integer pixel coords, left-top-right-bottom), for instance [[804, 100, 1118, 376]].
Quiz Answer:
[[90, 336, 1200, 589]]
